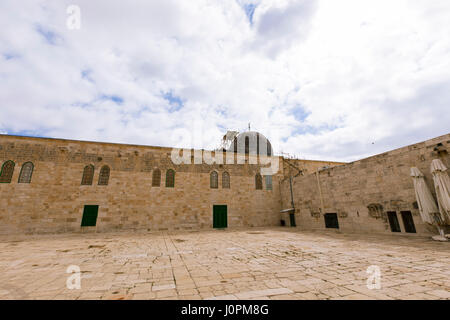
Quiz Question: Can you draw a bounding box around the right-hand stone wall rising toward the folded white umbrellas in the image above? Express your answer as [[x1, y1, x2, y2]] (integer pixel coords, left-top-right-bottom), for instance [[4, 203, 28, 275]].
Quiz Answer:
[[281, 134, 450, 234]]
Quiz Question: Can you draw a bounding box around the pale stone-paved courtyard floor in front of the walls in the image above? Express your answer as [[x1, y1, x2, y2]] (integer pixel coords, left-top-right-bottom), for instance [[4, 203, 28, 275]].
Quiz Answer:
[[0, 227, 450, 300]]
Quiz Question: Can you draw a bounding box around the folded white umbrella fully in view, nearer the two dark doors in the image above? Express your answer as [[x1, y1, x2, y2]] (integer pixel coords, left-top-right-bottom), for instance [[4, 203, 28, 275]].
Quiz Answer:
[[411, 167, 439, 224]]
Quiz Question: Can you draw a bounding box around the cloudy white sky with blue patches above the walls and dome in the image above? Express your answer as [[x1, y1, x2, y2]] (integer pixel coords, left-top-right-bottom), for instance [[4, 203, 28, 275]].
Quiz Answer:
[[0, 0, 450, 161]]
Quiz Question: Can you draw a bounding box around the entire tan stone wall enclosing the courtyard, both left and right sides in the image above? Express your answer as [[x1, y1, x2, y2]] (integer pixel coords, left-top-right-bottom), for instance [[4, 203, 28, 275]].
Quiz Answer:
[[4, 134, 450, 234]]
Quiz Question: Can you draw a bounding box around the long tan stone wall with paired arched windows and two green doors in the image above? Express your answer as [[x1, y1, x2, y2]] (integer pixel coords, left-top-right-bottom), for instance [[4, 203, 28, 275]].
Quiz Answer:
[[0, 135, 283, 234]]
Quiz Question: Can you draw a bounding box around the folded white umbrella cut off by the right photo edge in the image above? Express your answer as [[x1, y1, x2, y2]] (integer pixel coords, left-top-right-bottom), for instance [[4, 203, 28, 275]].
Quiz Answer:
[[431, 159, 450, 224]]
